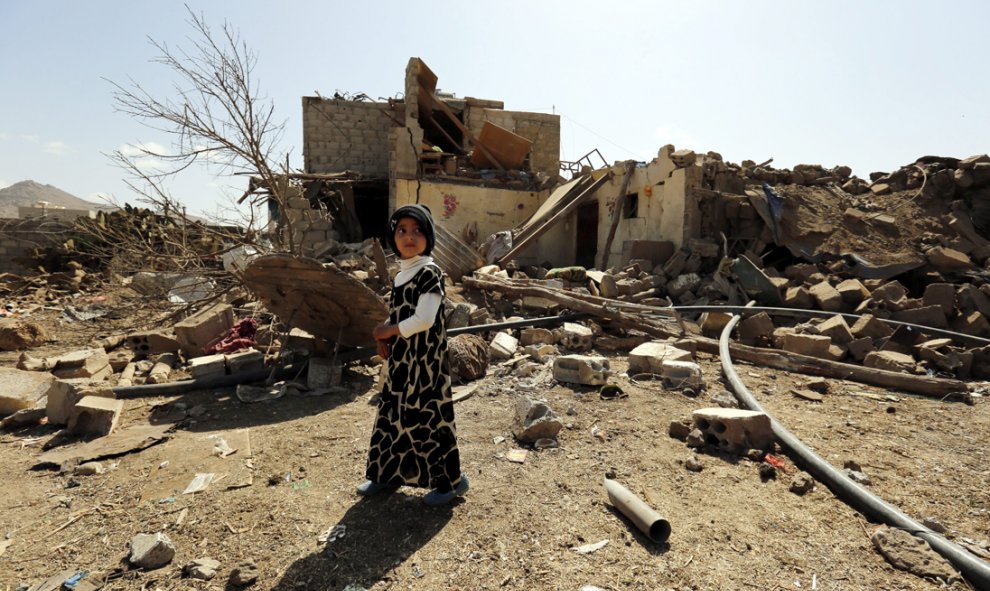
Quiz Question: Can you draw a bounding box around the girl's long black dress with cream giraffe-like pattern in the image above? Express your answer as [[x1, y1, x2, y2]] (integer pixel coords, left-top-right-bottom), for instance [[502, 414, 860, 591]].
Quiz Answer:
[[366, 263, 461, 492]]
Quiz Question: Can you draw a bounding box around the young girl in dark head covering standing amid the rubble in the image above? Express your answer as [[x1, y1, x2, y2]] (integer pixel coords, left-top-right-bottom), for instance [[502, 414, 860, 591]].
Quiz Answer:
[[357, 205, 469, 506]]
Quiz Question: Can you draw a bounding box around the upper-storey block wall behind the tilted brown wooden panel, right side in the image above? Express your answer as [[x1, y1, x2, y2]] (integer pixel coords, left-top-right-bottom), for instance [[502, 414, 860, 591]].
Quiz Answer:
[[465, 105, 560, 175]]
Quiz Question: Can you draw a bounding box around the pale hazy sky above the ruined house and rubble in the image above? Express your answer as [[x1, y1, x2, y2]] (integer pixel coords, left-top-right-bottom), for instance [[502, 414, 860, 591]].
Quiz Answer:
[[0, 0, 990, 213]]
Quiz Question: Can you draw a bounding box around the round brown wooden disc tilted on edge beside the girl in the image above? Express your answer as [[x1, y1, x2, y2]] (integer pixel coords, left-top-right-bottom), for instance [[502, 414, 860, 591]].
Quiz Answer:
[[244, 254, 388, 347]]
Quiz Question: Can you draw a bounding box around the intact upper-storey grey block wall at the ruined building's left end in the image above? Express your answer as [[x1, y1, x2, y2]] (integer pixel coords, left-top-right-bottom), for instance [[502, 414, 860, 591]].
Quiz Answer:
[[303, 96, 395, 178]]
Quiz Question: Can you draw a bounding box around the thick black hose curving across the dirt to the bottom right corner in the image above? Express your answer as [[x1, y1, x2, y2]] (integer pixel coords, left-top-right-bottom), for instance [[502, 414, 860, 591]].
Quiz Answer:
[[718, 315, 990, 591]]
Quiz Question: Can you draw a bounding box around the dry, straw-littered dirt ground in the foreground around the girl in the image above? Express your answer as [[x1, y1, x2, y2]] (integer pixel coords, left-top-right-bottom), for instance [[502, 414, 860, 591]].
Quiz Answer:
[[0, 288, 990, 591]]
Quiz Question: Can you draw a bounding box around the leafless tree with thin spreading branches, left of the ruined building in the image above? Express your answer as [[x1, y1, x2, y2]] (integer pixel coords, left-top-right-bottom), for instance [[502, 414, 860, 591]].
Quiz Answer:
[[109, 6, 297, 260]]
